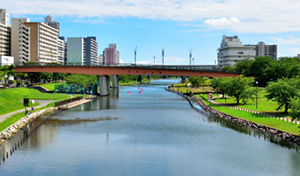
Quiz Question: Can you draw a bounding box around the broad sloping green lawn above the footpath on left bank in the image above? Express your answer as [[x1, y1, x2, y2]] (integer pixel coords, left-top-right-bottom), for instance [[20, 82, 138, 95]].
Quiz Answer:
[[0, 88, 70, 115]]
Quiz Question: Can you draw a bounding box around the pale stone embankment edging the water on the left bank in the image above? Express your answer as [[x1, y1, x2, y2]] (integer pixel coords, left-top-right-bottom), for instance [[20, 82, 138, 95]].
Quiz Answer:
[[0, 96, 95, 145]]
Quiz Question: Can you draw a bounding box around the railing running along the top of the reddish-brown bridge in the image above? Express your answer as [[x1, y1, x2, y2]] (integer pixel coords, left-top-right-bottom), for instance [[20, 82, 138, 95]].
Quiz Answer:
[[15, 62, 236, 72]]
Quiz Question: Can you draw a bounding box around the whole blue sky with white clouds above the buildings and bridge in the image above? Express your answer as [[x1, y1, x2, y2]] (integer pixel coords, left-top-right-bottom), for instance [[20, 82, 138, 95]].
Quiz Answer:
[[0, 0, 300, 65]]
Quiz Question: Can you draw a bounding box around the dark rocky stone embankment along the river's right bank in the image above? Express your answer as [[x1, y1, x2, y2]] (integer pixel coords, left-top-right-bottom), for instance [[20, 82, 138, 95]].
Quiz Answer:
[[166, 89, 300, 151]]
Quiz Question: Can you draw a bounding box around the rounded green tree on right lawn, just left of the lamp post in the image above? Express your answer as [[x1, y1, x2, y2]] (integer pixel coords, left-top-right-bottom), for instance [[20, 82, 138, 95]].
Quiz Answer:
[[226, 75, 255, 104]]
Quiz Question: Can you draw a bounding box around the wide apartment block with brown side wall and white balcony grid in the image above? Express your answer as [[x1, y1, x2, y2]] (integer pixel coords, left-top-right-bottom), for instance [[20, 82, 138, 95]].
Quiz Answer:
[[24, 22, 58, 63]]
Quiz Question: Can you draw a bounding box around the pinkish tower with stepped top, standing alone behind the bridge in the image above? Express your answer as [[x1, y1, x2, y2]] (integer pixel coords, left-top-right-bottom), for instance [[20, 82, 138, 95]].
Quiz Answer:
[[103, 44, 120, 65]]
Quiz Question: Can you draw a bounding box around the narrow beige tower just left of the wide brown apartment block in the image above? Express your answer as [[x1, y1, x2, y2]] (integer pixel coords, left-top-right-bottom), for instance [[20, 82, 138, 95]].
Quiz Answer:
[[11, 18, 30, 64]]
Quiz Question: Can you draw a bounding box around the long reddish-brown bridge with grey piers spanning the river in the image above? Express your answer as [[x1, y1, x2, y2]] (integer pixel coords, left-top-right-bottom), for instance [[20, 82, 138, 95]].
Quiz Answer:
[[14, 63, 241, 95]]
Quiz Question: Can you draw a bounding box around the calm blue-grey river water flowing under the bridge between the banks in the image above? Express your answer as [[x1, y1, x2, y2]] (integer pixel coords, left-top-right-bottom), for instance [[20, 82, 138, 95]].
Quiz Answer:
[[0, 80, 300, 176]]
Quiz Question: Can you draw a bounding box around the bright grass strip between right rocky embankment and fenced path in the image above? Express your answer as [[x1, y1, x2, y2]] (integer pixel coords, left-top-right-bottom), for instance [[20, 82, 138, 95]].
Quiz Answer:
[[197, 95, 300, 135]]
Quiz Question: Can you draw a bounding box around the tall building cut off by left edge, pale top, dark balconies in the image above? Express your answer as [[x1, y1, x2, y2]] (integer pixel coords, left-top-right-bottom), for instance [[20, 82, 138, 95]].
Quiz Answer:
[[0, 9, 11, 56]]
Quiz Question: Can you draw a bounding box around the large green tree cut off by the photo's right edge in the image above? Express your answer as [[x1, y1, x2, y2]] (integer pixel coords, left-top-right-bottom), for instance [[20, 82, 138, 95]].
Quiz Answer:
[[265, 76, 300, 113]]
